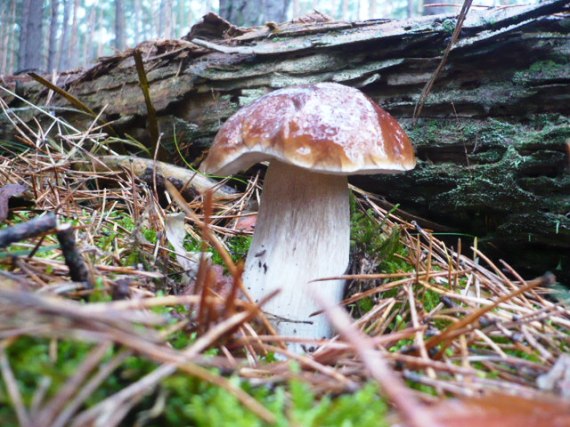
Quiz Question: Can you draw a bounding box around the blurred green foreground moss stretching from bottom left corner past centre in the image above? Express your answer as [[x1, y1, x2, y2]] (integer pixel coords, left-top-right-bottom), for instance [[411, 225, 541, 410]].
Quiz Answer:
[[0, 337, 388, 427]]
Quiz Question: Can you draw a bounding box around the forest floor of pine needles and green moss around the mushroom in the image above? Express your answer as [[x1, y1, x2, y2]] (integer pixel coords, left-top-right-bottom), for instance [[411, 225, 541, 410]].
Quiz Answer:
[[0, 102, 570, 426]]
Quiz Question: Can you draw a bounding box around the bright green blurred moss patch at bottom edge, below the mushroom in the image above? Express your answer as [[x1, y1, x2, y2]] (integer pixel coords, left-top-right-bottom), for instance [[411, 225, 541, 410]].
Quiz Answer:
[[160, 376, 388, 427]]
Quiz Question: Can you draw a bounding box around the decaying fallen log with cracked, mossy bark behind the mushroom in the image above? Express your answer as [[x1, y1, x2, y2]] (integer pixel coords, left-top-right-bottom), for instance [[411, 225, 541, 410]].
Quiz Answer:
[[0, 0, 570, 282]]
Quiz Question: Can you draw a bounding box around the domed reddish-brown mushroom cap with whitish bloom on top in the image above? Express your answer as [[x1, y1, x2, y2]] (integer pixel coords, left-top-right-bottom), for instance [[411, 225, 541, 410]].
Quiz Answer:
[[201, 83, 416, 175]]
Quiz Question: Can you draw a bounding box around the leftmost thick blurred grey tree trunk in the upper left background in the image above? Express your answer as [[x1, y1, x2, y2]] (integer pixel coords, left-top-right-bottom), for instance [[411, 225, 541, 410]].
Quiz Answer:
[[18, 0, 44, 70]]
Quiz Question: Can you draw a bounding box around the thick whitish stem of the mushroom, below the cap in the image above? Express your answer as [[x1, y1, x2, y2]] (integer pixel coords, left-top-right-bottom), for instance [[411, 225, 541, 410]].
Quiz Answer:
[[244, 160, 350, 351]]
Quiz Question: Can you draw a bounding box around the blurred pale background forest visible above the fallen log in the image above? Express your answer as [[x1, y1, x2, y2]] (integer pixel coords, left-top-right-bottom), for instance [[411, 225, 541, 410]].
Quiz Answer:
[[0, 0, 536, 75]]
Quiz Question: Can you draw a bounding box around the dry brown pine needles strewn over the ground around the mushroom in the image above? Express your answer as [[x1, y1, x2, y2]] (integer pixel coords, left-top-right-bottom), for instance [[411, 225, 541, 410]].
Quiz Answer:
[[0, 98, 570, 426]]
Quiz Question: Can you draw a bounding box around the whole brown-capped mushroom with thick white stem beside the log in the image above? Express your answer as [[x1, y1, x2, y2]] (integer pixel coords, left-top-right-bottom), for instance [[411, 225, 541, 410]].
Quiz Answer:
[[201, 83, 416, 351]]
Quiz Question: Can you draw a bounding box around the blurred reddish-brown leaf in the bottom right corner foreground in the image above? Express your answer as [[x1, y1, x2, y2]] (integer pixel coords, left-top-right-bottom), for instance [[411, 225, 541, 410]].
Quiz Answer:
[[432, 394, 570, 427]]
